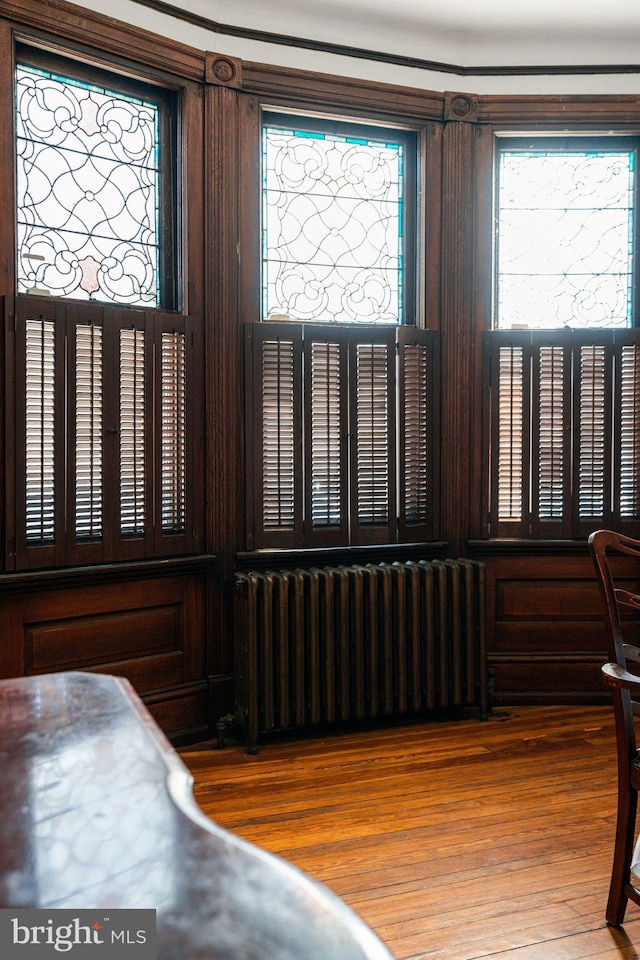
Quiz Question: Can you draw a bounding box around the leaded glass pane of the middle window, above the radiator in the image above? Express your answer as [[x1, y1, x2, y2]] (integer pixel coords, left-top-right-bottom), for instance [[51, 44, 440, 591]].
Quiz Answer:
[[262, 126, 404, 323]]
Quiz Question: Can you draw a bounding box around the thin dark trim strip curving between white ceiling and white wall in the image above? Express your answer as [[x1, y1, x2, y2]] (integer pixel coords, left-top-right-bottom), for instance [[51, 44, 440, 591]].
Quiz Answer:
[[116, 0, 640, 77]]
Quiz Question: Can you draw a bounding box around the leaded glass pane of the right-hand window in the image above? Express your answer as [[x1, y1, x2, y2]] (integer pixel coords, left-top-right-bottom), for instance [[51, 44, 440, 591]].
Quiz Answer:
[[496, 147, 635, 329]]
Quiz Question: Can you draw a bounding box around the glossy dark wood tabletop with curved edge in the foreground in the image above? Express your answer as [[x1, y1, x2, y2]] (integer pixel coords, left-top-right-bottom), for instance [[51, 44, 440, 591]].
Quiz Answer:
[[0, 673, 391, 960]]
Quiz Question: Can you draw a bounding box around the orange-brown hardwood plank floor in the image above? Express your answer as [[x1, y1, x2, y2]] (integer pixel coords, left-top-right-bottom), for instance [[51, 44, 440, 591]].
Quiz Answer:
[[181, 707, 640, 960]]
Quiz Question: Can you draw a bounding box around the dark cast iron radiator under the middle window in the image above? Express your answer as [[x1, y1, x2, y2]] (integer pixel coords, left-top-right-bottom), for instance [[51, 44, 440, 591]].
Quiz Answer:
[[234, 560, 487, 753]]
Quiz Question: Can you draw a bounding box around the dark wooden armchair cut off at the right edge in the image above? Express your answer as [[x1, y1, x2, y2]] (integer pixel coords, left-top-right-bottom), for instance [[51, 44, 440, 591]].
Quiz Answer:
[[589, 530, 640, 926]]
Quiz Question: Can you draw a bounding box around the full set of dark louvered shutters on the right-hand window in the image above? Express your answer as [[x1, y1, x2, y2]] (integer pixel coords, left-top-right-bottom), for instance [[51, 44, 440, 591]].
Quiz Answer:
[[488, 330, 640, 539]]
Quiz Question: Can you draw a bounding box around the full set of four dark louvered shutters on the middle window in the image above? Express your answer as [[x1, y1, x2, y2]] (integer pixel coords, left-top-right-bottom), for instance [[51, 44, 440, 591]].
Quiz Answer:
[[245, 323, 436, 549]]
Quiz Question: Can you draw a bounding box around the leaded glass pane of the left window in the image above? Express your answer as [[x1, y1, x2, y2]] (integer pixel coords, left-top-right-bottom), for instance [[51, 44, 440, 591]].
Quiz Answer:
[[16, 65, 160, 306]]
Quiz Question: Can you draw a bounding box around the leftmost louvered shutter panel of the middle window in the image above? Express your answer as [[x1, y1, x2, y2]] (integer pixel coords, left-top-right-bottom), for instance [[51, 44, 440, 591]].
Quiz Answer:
[[247, 323, 303, 547]]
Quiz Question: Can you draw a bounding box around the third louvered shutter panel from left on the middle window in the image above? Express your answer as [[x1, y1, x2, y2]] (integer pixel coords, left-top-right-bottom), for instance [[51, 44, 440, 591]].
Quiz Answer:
[[349, 328, 397, 544]]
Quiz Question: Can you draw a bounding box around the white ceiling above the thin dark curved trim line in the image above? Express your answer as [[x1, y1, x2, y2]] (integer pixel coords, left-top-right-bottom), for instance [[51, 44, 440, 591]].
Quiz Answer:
[[178, 0, 640, 67]]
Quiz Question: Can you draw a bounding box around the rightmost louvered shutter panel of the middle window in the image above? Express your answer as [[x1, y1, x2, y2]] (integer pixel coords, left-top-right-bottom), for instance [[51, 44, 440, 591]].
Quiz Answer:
[[396, 327, 439, 541]]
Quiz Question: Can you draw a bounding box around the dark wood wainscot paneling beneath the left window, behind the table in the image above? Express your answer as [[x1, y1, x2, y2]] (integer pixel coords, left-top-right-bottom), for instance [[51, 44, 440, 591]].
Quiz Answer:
[[0, 571, 207, 734]]
